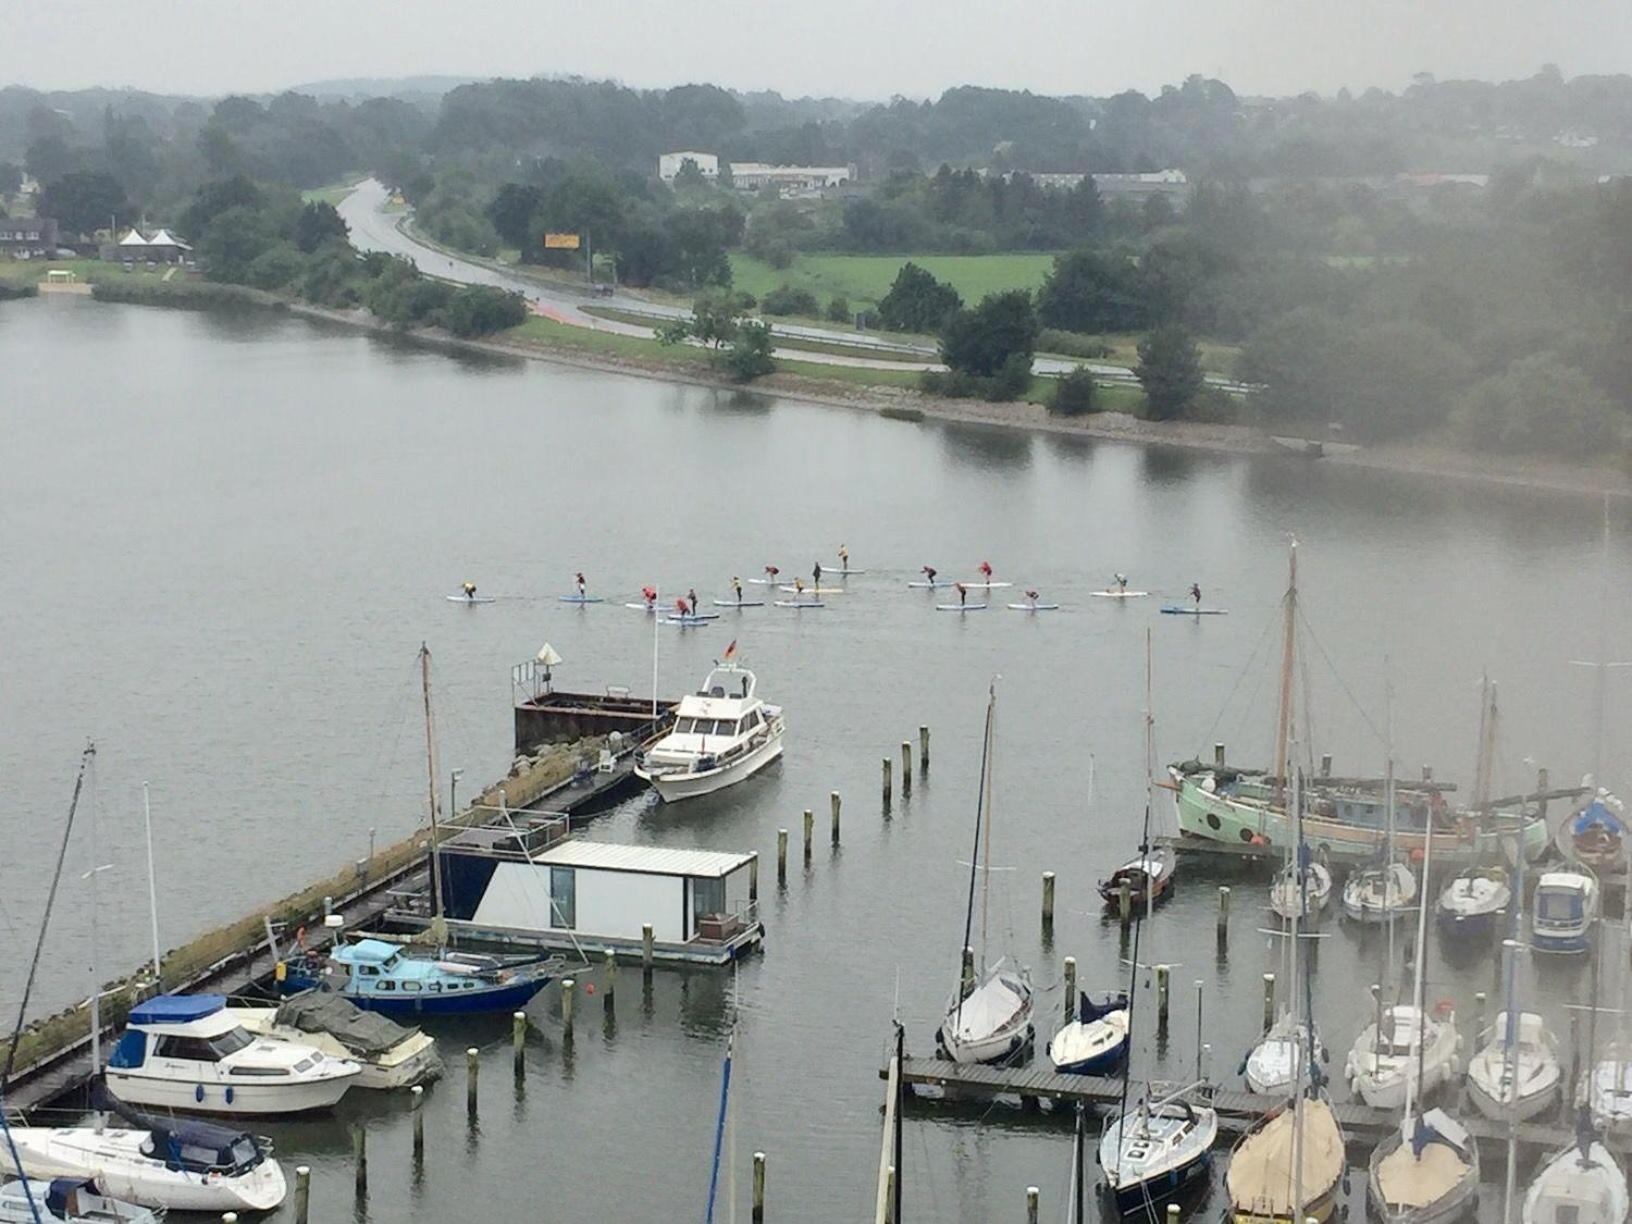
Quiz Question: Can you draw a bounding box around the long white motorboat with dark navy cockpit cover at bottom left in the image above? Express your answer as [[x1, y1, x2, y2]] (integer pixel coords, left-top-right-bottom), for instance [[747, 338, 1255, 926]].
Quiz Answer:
[[11, 1118, 286, 1214]]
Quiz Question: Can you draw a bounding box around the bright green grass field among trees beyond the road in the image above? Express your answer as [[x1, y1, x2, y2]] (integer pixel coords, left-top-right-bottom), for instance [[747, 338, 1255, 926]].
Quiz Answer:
[[731, 251, 1054, 307]]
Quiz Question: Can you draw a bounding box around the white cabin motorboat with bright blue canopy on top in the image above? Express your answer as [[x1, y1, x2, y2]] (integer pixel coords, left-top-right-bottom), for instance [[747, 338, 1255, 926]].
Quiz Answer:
[[104, 994, 362, 1115]]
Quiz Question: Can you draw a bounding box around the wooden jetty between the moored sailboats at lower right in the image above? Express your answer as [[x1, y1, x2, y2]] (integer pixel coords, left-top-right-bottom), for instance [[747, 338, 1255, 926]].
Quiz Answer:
[[878, 1058, 1632, 1152]]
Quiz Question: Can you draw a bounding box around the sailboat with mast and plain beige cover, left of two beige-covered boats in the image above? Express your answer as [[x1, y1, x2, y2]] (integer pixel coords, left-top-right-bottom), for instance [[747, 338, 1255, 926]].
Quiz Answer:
[[1224, 763, 1345, 1224]]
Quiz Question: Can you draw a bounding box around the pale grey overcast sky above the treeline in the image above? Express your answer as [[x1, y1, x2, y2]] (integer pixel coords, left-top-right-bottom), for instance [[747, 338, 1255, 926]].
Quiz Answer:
[[0, 0, 1632, 98]]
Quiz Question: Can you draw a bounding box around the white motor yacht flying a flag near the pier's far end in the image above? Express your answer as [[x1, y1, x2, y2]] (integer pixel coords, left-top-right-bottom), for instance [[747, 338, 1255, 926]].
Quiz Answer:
[[635, 662, 783, 803]]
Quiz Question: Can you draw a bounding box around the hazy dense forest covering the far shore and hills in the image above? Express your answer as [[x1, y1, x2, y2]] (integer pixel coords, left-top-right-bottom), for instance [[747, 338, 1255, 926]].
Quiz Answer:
[[9, 67, 1632, 457]]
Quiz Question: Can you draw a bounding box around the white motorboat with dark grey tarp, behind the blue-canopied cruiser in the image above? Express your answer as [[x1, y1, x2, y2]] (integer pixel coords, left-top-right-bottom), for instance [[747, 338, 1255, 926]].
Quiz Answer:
[[227, 991, 442, 1090]]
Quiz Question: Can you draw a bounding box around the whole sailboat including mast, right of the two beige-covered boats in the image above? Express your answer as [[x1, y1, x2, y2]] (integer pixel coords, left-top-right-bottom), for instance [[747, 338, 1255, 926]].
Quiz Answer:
[[1351, 786, 1479, 1224]]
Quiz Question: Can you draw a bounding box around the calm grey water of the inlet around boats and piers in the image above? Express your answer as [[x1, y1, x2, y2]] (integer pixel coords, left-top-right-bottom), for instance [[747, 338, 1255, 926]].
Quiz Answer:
[[0, 292, 1632, 1222]]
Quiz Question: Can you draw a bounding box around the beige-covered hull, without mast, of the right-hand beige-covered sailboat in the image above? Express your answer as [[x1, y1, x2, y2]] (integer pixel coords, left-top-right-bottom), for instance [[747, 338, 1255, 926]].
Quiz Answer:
[[1366, 1110, 1479, 1224]]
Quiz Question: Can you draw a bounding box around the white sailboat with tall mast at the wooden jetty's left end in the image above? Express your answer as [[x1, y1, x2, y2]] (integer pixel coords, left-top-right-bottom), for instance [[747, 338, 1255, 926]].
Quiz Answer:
[[935, 682, 1035, 1062]]
